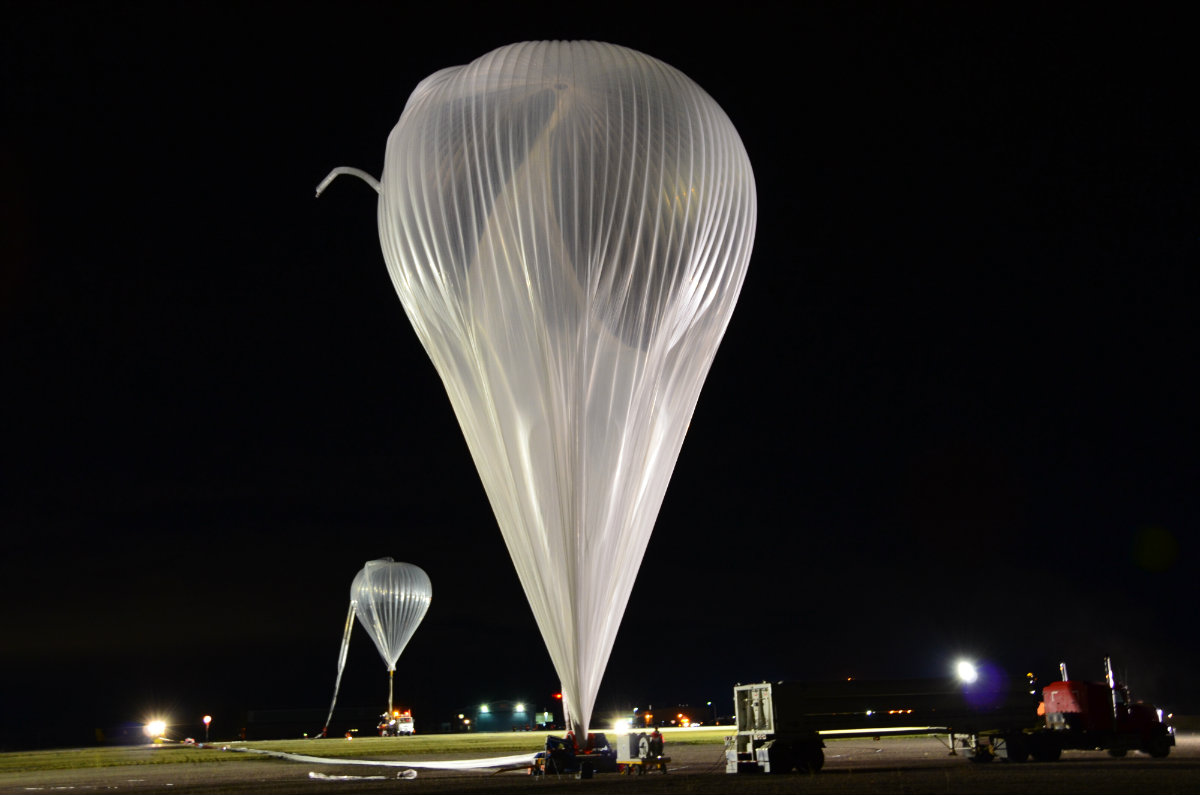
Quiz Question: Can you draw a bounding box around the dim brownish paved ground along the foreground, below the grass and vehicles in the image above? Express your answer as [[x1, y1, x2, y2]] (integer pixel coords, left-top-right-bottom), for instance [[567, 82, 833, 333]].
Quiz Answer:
[[9, 731, 1200, 795]]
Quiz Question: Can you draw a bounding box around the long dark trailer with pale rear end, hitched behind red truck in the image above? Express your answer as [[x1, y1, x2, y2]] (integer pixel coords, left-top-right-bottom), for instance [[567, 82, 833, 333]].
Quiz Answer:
[[725, 676, 1038, 773]]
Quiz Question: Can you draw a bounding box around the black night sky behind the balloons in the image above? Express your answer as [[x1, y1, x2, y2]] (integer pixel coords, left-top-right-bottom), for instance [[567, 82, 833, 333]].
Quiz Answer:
[[0, 2, 1200, 747]]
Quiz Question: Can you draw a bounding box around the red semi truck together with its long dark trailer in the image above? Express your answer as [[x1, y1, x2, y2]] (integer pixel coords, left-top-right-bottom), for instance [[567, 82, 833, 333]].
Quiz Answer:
[[726, 658, 1175, 773]]
